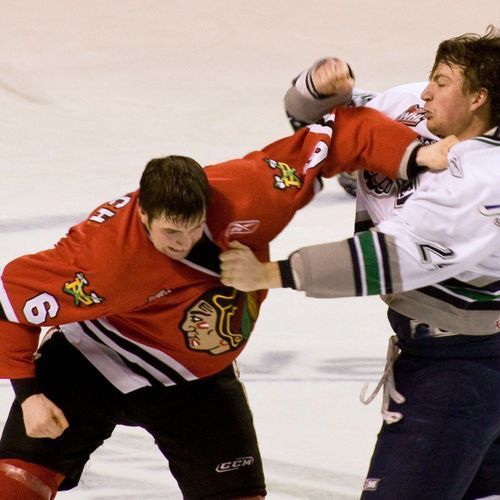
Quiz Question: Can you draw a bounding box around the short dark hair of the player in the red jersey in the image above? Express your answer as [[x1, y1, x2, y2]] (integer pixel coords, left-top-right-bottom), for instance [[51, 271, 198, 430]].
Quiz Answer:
[[139, 156, 210, 224]]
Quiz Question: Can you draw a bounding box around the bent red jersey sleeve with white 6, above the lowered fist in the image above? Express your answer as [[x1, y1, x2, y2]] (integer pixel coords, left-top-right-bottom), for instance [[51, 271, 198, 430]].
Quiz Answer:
[[0, 240, 129, 376]]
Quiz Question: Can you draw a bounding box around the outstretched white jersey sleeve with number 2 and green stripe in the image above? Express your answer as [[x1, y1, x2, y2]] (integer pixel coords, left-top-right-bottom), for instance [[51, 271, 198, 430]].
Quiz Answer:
[[280, 164, 500, 297]]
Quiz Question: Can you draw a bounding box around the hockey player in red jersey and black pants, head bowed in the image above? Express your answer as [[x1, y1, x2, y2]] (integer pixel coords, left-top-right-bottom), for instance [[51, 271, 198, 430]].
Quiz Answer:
[[0, 105, 438, 500]]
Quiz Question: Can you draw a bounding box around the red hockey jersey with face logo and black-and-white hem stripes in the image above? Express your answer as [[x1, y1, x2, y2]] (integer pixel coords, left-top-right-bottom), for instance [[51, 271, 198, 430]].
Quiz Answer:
[[0, 108, 415, 384]]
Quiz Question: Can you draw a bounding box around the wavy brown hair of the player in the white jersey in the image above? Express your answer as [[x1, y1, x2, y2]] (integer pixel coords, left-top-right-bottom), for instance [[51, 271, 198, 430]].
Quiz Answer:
[[431, 24, 500, 125]]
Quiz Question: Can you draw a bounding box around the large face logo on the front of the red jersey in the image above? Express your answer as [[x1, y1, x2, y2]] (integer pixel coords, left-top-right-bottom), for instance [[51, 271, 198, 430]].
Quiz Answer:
[[179, 287, 259, 355]]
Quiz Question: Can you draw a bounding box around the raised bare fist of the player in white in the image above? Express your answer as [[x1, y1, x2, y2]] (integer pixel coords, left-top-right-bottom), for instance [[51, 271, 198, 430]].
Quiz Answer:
[[311, 57, 354, 97]]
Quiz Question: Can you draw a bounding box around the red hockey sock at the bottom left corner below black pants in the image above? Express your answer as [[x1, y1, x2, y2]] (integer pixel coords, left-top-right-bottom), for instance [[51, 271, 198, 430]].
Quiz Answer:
[[0, 458, 64, 500]]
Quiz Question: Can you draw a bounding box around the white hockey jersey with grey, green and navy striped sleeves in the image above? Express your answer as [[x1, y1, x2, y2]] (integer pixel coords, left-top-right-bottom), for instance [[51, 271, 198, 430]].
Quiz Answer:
[[284, 68, 500, 335]]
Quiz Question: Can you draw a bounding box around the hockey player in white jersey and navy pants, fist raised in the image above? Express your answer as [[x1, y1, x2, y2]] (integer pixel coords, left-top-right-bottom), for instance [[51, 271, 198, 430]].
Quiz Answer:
[[222, 27, 500, 500]]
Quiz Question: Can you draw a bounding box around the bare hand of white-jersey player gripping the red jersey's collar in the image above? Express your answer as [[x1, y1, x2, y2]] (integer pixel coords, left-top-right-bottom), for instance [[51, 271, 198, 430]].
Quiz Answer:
[[220, 241, 281, 292]]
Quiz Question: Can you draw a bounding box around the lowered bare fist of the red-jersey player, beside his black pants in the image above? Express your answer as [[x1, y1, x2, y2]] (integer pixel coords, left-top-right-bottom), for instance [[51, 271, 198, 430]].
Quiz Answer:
[[21, 394, 69, 439]]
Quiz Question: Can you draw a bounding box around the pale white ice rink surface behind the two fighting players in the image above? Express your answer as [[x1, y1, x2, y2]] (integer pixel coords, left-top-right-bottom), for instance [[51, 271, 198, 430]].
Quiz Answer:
[[0, 0, 500, 500]]
